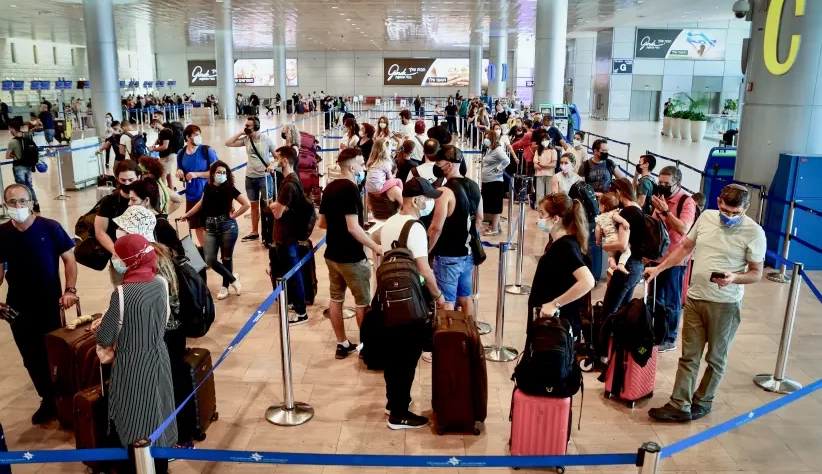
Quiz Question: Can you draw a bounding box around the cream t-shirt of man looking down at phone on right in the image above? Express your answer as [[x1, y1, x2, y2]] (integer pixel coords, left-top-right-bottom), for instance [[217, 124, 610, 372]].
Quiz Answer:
[[688, 210, 767, 303]]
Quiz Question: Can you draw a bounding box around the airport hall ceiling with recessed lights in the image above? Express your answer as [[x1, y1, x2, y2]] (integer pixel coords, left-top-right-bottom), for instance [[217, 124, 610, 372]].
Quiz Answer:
[[0, 0, 733, 50]]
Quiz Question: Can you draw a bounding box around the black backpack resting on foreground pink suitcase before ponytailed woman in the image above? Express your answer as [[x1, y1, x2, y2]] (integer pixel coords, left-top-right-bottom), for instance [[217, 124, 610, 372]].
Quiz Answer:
[[511, 308, 582, 398]]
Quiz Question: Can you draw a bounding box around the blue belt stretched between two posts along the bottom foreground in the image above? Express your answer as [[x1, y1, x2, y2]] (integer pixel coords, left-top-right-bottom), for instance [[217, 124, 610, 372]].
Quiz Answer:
[[151, 446, 638, 469]]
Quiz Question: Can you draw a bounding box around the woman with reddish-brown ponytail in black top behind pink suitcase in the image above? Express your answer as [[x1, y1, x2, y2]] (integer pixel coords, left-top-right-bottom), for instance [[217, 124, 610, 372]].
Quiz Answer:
[[527, 193, 595, 337]]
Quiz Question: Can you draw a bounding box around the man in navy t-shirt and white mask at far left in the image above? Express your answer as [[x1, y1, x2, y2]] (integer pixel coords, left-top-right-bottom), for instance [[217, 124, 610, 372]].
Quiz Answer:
[[0, 184, 78, 425]]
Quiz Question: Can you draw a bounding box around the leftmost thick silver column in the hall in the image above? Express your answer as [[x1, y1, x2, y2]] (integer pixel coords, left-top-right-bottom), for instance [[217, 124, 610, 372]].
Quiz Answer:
[[83, 0, 123, 131]]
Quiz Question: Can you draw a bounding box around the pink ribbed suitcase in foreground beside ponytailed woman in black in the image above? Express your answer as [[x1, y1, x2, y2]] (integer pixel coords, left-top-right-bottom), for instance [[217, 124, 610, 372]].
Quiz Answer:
[[509, 389, 571, 472]]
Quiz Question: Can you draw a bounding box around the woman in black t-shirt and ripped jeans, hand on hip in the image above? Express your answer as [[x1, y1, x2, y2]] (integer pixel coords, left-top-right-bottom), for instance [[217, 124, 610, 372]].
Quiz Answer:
[[182, 161, 251, 300]]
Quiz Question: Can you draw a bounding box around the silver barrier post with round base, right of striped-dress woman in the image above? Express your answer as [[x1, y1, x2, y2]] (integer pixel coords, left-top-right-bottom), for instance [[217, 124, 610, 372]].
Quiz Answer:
[[265, 277, 314, 426]]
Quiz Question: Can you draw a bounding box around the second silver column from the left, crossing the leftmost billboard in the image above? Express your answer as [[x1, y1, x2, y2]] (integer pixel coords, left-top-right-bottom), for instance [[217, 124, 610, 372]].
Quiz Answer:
[[214, 0, 237, 119]]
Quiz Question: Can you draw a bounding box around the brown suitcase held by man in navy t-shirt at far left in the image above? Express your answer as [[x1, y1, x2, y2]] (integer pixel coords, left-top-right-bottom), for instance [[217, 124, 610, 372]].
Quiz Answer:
[[46, 302, 102, 428]]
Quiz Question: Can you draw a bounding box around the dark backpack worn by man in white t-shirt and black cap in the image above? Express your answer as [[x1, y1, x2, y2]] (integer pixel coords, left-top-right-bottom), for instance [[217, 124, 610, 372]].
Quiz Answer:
[[377, 220, 428, 327]]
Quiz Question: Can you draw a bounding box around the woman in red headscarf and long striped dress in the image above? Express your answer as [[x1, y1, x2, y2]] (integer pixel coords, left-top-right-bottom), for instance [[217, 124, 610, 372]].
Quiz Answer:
[[92, 234, 177, 474]]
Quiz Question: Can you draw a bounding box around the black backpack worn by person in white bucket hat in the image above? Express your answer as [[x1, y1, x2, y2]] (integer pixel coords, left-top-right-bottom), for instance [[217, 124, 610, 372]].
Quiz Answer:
[[174, 257, 215, 337]]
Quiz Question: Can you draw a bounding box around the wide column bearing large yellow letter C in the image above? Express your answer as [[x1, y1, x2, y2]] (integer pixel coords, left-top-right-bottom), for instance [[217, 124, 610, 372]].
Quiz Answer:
[[729, 0, 822, 187]]
